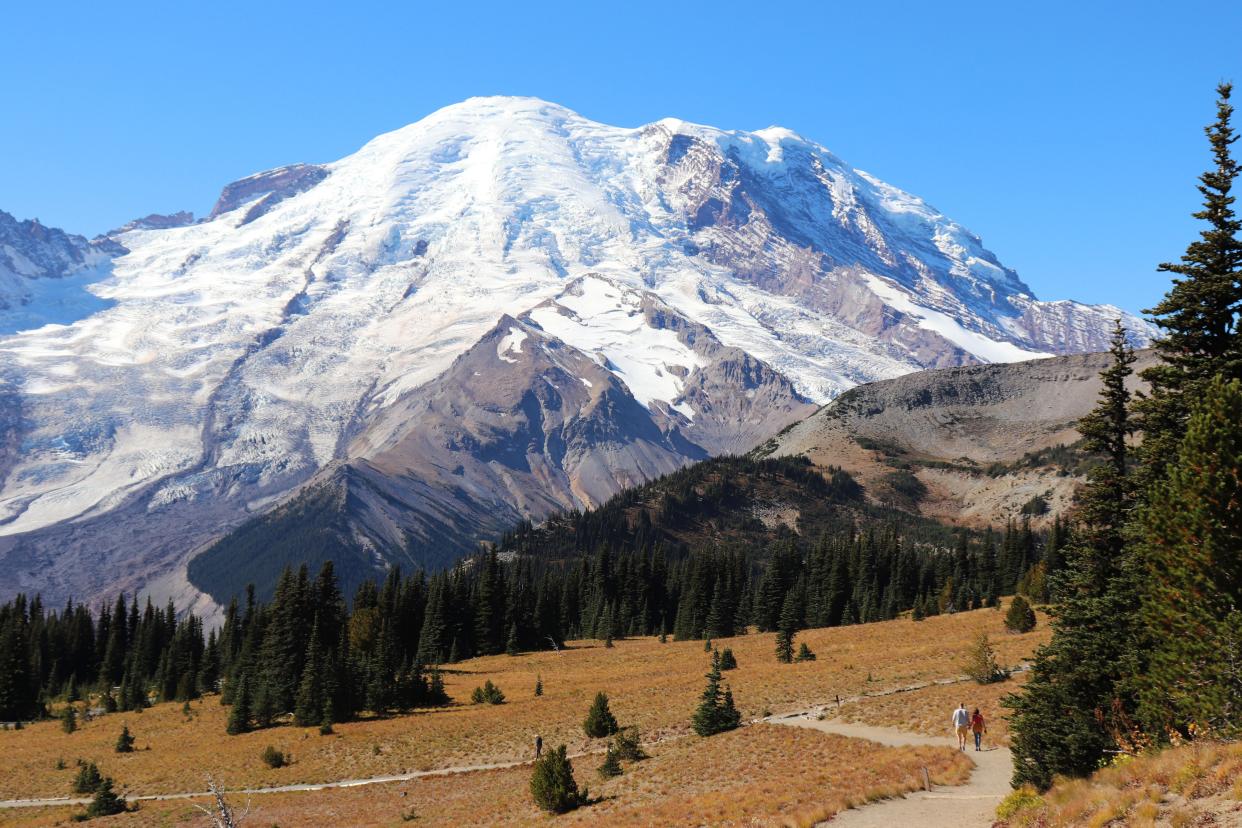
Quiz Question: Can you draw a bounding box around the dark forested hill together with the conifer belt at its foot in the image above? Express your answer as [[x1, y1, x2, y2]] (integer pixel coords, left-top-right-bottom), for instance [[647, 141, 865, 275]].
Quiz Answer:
[[0, 458, 1061, 731]]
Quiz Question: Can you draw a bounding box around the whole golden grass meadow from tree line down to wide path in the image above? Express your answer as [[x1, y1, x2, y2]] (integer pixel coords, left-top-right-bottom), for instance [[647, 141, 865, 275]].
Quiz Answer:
[[0, 610, 1047, 826]]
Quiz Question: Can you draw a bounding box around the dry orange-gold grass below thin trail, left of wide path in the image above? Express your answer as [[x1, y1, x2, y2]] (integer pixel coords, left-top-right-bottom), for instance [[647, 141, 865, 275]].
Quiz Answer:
[[0, 725, 970, 828]]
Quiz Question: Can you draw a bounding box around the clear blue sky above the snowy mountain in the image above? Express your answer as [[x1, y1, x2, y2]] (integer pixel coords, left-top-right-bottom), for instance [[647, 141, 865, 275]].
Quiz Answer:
[[0, 0, 1242, 310]]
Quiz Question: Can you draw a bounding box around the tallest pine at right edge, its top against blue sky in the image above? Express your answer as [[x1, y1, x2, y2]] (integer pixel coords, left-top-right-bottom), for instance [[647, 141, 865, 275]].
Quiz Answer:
[[1136, 83, 1242, 489]]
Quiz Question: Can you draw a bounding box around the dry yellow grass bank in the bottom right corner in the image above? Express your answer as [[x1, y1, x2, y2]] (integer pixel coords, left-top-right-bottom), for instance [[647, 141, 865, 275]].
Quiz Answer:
[[1000, 742, 1242, 828]]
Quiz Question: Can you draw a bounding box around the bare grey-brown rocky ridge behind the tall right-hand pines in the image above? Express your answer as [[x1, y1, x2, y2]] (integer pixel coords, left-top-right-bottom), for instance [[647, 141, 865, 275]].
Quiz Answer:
[[756, 351, 1155, 525]]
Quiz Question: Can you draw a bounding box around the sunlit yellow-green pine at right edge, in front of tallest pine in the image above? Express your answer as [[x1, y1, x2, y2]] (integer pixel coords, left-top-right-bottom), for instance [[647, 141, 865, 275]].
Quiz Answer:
[[1140, 377, 1242, 739]]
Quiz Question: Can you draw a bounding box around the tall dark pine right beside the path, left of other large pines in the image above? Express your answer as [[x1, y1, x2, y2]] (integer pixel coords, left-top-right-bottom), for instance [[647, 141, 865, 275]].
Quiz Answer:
[[1005, 323, 1138, 790]]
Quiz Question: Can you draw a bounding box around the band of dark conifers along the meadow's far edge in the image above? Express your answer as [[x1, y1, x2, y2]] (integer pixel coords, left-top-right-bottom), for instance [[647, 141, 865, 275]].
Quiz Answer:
[[0, 508, 1058, 732]]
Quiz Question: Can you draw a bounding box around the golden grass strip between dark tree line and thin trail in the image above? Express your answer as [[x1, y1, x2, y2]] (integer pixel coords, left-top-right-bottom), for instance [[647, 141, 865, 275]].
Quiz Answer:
[[0, 610, 1046, 824]]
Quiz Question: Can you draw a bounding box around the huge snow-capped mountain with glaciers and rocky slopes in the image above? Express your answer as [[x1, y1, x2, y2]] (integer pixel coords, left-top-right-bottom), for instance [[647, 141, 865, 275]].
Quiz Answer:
[[0, 98, 1150, 605]]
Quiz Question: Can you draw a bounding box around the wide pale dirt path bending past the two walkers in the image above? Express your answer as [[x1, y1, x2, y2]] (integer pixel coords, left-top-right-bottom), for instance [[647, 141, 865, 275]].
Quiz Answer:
[[768, 713, 1013, 828]]
